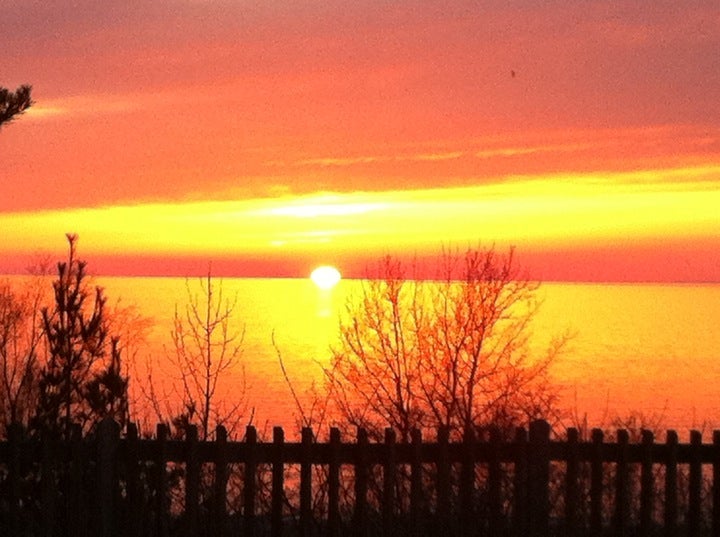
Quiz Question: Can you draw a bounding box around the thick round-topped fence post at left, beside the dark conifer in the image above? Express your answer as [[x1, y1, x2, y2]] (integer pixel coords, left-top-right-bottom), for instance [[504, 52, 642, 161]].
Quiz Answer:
[[98, 417, 120, 537]]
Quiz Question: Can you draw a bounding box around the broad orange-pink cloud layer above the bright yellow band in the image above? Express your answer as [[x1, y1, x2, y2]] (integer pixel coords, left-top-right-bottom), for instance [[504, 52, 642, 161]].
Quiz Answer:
[[0, 0, 720, 218]]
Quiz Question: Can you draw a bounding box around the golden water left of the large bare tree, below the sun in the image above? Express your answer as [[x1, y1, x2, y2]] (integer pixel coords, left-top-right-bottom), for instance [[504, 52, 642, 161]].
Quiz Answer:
[[97, 278, 346, 430]]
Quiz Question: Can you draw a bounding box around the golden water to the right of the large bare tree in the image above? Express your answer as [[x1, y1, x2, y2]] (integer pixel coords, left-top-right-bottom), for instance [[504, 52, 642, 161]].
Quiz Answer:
[[537, 284, 720, 429]]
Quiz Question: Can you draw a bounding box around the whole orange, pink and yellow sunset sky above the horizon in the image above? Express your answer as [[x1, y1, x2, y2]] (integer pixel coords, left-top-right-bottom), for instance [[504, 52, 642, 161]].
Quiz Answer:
[[0, 0, 720, 282]]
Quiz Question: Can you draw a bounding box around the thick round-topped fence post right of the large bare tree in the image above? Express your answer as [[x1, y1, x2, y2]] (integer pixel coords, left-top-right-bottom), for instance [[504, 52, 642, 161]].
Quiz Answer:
[[528, 420, 550, 537]]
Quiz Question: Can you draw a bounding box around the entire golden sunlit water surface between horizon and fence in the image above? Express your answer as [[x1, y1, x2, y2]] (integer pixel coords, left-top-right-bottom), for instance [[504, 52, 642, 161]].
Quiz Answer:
[[1, 277, 720, 430]]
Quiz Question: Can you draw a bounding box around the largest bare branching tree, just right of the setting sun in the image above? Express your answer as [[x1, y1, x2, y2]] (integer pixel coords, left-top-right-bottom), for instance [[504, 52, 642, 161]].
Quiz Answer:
[[325, 249, 567, 442]]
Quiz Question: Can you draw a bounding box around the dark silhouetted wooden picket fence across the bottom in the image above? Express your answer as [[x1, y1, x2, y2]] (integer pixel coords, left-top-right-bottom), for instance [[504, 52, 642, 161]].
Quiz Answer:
[[0, 420, 720, 537]]
